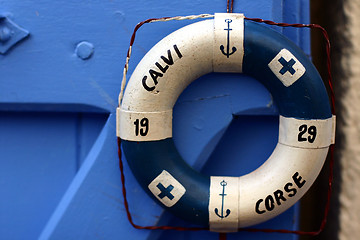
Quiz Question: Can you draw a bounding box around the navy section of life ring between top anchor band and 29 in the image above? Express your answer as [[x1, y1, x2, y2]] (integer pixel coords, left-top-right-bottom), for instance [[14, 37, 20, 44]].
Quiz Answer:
[[243, 20, 332, 119]]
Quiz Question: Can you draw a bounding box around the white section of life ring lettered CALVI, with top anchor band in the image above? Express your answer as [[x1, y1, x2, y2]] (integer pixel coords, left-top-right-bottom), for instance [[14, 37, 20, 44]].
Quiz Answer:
[[121, 14, 243, 112]]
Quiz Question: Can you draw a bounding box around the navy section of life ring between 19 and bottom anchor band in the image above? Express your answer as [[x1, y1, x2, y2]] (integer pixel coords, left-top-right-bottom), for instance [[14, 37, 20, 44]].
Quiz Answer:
[[121, 138, 210, 226]]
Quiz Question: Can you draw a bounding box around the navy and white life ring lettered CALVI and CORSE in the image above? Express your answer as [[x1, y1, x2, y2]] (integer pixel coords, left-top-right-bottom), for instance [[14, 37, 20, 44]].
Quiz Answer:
[[117, 13, 335, 231]]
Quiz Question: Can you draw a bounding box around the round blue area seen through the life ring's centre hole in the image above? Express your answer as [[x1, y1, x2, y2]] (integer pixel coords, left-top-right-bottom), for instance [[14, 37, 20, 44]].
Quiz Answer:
[[173, 73, 279, 176]]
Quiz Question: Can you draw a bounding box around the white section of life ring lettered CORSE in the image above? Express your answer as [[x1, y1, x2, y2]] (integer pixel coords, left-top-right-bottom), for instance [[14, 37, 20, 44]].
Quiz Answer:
[[239, 143, 328, 227]]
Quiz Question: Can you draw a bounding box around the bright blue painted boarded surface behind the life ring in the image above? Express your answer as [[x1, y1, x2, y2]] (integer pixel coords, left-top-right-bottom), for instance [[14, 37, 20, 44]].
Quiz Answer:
[[0, 0, 309, 239]]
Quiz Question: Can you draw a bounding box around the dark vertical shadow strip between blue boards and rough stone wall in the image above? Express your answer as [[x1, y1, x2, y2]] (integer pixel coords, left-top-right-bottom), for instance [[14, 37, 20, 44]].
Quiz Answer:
[[300, 0, 349, 240]]
